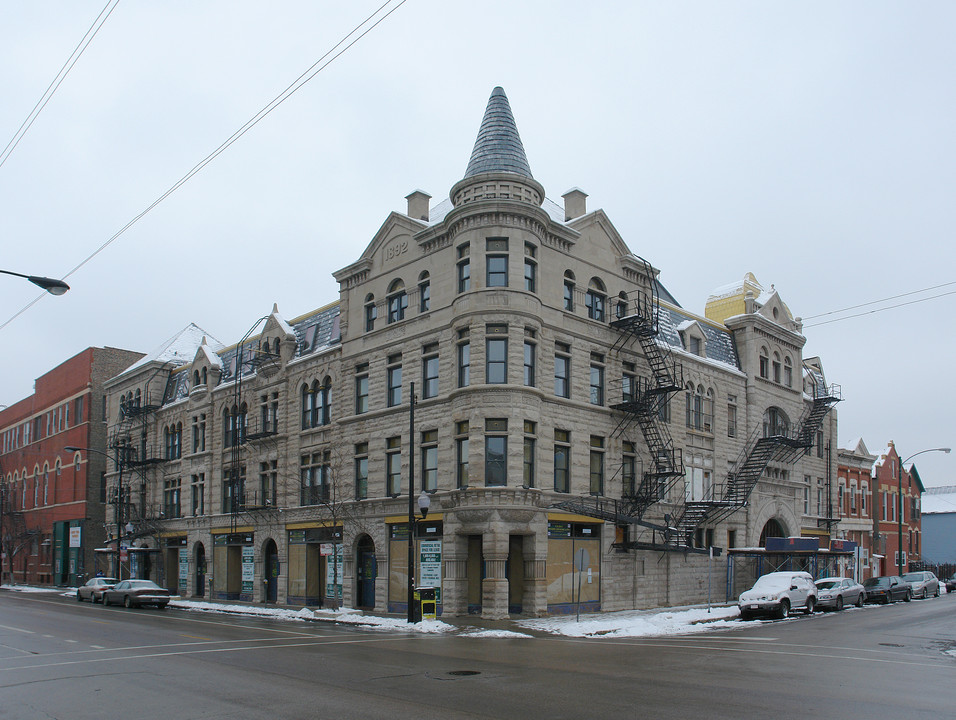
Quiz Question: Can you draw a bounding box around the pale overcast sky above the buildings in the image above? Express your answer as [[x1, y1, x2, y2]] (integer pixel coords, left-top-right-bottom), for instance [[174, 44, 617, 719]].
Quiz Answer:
[[0, 0, 956, 486]]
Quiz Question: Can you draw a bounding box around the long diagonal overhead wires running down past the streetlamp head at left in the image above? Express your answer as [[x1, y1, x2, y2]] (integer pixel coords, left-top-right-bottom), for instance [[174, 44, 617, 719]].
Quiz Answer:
[[0, 0, 407, 330]]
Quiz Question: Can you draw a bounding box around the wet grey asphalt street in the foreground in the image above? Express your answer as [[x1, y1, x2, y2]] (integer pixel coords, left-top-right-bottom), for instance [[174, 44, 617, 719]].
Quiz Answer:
[[0, 591, 956, 720]]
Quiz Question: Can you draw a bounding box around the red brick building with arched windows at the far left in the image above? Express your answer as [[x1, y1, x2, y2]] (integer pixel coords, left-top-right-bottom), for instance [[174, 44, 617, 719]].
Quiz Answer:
[[0, 348, 142, 585]]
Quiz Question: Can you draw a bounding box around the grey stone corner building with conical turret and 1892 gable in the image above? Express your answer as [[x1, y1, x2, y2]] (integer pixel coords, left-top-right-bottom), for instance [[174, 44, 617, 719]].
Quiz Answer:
[[101, 88, 836, 618]]
